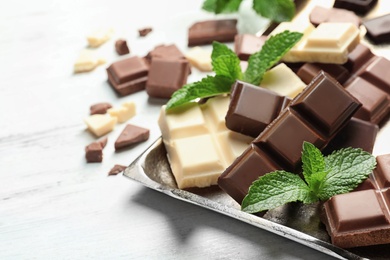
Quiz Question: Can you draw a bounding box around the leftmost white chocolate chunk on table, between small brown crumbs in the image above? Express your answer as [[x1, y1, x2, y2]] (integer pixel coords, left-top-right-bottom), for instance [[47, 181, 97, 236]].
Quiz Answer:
[[84, 114, 117, 137]]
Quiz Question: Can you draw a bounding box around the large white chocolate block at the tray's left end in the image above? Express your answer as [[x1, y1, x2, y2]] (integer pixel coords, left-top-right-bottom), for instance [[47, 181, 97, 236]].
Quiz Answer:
[[158, 96, 253, 189]]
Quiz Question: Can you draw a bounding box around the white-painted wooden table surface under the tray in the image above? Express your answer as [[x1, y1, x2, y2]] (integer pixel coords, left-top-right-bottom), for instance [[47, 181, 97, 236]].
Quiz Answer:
[[0, 0, 388, 259]]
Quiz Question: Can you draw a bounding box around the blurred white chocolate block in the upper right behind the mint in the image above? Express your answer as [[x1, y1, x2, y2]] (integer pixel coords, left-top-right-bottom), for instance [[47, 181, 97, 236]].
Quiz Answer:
[[271, 22, 360, 64]]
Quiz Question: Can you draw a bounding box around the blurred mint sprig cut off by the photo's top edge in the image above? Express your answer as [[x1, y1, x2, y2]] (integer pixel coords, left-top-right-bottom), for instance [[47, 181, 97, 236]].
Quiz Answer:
[[202, 0, 295, 22]]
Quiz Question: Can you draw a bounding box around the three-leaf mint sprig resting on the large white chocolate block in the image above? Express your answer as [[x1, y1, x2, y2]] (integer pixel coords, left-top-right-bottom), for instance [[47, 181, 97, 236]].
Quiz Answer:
[[166, 31, 302, 110]]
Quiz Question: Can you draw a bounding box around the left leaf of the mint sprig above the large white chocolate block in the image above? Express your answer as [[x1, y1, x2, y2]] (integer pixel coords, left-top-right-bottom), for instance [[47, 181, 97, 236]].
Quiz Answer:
[[165, 75, 235, 110]]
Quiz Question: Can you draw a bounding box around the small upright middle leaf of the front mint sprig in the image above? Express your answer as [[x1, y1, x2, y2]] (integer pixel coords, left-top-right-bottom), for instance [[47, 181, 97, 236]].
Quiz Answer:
[[302, 141, 325, 186]]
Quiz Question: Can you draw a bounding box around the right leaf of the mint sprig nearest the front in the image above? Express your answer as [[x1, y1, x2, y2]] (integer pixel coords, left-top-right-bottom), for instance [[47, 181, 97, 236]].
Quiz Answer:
[[317, 148, 376, 200]]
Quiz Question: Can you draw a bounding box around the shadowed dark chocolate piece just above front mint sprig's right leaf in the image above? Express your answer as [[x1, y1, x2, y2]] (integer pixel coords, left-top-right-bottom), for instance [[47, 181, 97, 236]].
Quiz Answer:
[[322, 117, 379, 155]]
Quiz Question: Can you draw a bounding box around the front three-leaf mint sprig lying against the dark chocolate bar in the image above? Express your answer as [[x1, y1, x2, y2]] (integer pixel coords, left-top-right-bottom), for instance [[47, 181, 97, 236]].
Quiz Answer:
[[241, 142, 376, 213]]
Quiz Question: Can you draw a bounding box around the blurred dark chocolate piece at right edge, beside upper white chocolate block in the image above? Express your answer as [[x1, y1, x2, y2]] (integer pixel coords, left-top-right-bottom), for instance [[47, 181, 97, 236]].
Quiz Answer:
[[363, 14, 390, 44]]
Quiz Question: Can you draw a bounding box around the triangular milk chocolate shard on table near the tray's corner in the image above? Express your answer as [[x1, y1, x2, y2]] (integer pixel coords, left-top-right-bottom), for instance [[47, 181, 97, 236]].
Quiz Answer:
[[115, 124, 149, 150]]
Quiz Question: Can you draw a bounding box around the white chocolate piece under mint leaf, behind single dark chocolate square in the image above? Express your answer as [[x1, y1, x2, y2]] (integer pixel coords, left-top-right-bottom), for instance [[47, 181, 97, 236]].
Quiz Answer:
[[260, 63, 306, 98]]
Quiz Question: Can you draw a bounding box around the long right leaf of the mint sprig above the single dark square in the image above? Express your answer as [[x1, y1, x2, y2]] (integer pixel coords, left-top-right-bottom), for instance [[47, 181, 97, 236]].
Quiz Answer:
[[243, 31, 303, 85]]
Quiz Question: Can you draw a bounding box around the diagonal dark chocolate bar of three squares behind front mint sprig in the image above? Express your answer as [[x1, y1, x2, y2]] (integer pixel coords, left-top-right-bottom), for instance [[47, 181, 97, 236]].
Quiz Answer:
[[218, 72, 360, 203]]
